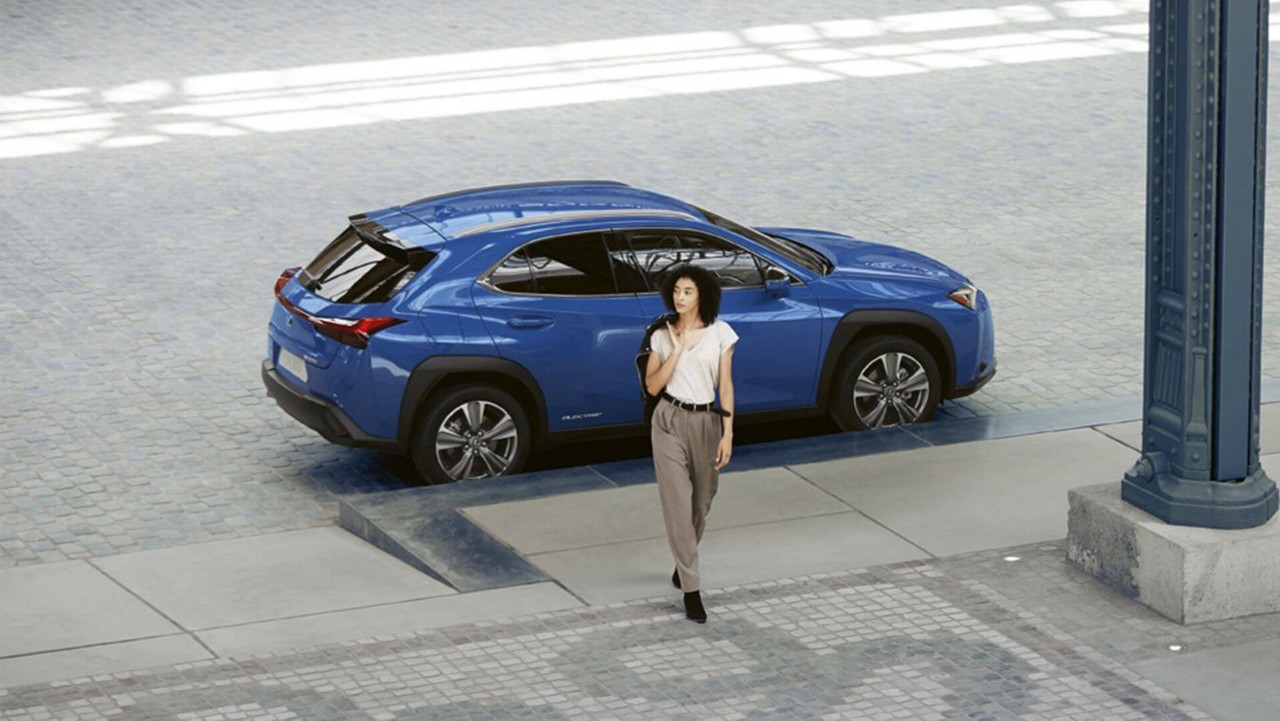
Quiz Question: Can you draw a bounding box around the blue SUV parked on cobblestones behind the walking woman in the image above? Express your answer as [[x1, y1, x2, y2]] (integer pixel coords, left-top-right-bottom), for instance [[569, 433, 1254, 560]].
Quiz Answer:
[[262, 181, 996, 483]]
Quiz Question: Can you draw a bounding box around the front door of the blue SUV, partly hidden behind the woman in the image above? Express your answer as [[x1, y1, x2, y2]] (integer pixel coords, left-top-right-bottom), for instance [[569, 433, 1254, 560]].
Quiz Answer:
[[620, 228, 822, 412]]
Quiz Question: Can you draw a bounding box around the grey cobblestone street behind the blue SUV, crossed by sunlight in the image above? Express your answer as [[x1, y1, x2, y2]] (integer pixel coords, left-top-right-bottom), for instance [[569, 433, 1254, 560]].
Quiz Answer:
[[0, 0, 1280, 566]]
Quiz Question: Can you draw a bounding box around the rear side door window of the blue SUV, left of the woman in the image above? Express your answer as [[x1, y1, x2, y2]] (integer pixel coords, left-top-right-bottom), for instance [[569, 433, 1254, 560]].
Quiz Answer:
[[489, 233, 617, 296]]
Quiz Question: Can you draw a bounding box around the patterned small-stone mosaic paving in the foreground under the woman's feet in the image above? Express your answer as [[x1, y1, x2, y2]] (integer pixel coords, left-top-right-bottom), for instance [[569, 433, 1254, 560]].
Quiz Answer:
[[0, 543, 1280, 721]]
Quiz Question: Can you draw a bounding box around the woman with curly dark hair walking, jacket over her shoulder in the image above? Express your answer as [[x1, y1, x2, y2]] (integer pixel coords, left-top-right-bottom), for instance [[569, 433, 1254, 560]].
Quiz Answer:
[[645, 264, 737, 624]]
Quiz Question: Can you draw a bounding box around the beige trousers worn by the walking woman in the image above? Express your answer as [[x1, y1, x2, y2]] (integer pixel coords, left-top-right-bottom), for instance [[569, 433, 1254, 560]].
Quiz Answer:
[[652, 400, 721, 593]]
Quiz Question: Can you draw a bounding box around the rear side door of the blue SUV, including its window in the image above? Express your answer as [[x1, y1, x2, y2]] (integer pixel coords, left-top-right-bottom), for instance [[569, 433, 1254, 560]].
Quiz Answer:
[[471, 232, 645, 432]]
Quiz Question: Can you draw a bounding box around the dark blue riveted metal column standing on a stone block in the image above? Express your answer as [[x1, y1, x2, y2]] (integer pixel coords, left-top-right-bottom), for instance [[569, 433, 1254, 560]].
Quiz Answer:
[[1121, 0, 1277, 528]]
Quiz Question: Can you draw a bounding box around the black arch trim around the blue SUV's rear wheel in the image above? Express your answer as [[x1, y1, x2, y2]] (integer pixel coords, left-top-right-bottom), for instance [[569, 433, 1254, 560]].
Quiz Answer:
[[397, 356, 547, 453]]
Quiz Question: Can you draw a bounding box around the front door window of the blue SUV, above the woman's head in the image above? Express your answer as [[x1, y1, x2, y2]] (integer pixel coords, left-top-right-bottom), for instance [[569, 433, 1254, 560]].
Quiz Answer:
[[627, 231, 764, 289]]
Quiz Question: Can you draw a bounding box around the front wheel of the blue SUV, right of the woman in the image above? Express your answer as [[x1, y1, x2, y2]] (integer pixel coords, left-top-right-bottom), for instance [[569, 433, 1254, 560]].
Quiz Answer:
[[831, 336, 942, 430]]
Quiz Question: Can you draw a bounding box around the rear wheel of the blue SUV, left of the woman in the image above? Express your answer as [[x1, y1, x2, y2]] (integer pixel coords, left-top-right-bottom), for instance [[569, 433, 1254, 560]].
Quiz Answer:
[[410, 383, 532, 483]]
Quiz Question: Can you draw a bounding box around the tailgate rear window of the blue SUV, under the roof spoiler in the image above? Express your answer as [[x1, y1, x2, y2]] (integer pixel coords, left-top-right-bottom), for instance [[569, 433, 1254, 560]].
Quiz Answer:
[[300, 224, 435, 304]]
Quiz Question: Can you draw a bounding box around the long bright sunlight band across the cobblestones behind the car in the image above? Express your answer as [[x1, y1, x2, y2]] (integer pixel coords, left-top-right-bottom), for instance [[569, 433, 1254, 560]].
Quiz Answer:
[[0, 0, 1162, 159]]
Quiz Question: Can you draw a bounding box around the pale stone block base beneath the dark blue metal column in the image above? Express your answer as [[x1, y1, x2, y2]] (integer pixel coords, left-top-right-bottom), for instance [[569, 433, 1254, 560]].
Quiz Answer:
[[1066, 483, 1280, 624]]
